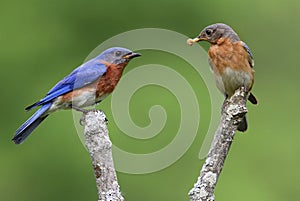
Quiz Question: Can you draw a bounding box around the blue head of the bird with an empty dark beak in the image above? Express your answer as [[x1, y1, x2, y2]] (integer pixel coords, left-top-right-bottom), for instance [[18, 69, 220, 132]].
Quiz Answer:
[[97, 47, 141, 66]]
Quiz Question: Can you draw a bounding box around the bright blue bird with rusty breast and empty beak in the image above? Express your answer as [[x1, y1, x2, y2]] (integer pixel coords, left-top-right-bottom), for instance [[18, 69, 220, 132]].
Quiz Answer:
[[12, 47, 141, 144]]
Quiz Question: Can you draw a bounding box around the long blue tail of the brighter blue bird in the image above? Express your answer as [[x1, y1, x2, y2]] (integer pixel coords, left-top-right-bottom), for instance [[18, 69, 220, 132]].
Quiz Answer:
[[12, 103, 52, 144]]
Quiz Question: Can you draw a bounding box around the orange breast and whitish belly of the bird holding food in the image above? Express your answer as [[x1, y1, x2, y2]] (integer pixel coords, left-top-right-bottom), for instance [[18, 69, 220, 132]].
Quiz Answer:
[[208, 39, 254, 96]]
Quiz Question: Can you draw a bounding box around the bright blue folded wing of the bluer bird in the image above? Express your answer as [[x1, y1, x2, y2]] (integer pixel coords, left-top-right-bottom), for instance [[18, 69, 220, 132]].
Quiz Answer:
[[26, 59, 106, 110]]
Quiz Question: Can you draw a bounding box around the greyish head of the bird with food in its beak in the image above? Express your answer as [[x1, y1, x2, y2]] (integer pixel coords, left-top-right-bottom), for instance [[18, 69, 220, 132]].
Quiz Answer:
[[192, 23, 240, 44]]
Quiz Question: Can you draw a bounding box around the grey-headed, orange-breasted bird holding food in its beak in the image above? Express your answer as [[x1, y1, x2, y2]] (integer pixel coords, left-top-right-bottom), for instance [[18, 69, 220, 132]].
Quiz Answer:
[[187, 23, 257, 132]]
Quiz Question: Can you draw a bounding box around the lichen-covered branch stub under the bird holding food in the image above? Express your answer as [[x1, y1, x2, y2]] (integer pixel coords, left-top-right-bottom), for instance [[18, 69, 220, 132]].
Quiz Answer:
[[189, 87, 247, 201]]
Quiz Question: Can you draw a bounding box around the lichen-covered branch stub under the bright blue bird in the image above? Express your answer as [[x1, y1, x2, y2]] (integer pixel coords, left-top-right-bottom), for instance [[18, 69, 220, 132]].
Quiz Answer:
[[83, 110, 124, 201]]
